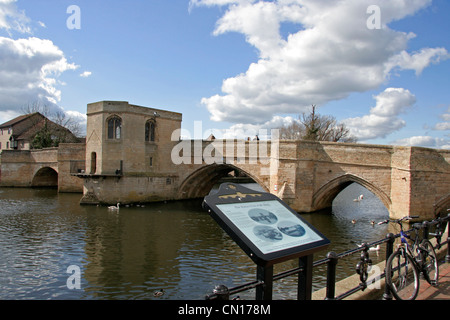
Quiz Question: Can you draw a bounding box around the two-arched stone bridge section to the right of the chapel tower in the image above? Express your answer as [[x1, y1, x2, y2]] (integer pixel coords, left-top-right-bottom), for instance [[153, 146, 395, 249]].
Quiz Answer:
[[176, 141, 450, 218]]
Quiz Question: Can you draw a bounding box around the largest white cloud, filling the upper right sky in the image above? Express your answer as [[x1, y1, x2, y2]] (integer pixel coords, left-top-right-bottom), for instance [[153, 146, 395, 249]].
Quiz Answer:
[[190, 0, 449, 125]]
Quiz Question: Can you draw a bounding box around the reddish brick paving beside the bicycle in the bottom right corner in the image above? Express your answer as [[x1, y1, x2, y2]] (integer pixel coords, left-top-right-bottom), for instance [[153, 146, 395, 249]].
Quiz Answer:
[[416, 262, 450, 300]]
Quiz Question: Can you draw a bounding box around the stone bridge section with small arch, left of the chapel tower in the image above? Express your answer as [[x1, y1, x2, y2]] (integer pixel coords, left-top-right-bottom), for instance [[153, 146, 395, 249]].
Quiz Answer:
[[0, 144, 86, 193]]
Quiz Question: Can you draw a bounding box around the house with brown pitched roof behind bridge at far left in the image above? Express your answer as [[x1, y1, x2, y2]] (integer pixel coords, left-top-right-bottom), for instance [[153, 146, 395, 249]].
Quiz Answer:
[[0, 112, 79, 152]]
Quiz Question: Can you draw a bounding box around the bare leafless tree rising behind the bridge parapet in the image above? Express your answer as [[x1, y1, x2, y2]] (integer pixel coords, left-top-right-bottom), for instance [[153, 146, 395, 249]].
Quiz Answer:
[[280, 105, 357, 142]]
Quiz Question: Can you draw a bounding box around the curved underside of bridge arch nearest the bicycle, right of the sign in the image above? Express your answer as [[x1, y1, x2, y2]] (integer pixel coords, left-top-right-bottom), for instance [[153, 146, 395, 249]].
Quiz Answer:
[[312, 174, 392, 211]]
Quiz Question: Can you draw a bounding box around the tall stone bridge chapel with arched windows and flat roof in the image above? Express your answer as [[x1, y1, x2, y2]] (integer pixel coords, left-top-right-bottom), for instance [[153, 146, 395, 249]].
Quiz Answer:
[[80, 101, 182, 203]]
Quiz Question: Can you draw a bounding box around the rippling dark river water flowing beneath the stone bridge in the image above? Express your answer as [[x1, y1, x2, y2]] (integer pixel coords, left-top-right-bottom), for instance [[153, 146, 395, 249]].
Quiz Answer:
[[0, 184, 388, 300]]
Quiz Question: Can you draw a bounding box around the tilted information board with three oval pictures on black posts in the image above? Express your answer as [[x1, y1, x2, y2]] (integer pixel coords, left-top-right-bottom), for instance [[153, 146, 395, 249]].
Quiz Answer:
[[203, 183, 330, 300]]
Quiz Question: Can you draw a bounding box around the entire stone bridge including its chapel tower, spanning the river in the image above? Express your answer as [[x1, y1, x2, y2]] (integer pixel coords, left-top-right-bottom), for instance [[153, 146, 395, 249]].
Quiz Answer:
[[1, 101, 450, 219]]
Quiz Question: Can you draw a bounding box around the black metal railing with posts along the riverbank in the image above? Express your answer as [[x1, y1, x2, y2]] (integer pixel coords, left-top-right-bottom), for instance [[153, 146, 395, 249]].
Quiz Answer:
[[205, 214, 450, 300]]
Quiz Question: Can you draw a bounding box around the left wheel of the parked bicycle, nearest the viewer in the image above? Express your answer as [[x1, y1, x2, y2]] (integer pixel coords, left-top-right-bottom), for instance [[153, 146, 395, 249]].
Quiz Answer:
[[386, 248, 419, 300]]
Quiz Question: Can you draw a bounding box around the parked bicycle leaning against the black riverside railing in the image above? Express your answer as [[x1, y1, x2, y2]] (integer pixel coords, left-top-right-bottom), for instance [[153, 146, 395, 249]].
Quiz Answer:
[[378, 216, 439, 300]]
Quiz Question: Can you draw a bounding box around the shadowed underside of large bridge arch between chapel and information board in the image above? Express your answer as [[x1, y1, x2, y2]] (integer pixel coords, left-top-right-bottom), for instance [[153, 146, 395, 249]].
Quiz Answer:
[[178, 164, 268, 199]]
